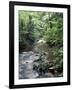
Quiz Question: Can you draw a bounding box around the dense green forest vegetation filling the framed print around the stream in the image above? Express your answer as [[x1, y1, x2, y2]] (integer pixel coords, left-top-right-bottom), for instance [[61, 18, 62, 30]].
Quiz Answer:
[[19, 10, 63, 76]]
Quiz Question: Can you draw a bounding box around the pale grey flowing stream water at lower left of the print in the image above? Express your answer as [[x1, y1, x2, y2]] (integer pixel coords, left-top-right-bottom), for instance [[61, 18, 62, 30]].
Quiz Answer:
[[19, 51, 40, 79]]
